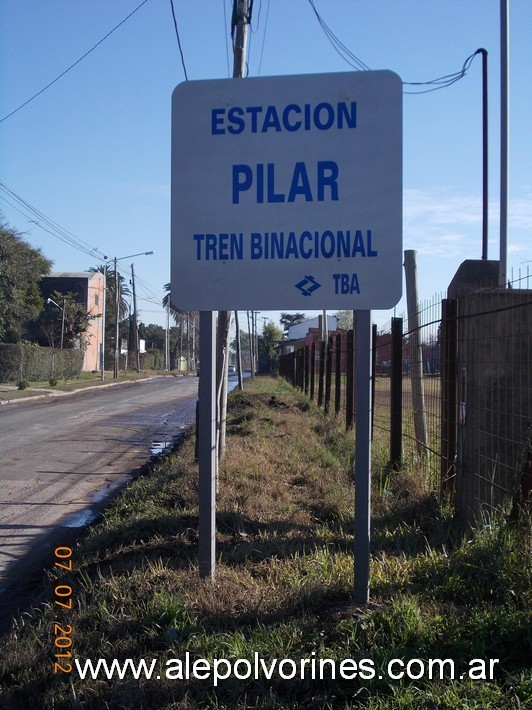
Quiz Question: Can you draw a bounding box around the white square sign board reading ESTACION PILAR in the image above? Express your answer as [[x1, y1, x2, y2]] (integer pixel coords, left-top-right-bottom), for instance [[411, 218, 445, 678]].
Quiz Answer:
[[171, 71, 402, 311]]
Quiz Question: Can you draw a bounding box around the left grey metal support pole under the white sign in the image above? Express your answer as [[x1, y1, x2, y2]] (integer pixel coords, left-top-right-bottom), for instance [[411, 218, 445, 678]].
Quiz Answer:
[[198, 311, 218, 579]]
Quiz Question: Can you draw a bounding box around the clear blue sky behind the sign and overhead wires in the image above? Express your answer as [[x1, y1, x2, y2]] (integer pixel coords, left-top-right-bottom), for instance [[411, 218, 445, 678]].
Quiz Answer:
[[0, 0, 532, 334]]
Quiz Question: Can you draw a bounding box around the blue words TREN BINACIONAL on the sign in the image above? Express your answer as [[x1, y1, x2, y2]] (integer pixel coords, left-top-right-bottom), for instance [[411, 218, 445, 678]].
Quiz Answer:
[[193, 229, 378, 261]]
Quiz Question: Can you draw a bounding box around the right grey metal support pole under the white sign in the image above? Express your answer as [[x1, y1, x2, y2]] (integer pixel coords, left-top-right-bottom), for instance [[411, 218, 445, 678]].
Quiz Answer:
[[353, 311, 372, 604]]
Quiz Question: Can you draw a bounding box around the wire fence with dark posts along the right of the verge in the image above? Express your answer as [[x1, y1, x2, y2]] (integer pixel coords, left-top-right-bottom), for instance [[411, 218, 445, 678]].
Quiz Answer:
[[280, 276, 532, 523]]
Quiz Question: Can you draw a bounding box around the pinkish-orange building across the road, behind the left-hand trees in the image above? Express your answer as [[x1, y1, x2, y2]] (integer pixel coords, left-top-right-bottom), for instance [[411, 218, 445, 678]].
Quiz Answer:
[[41, 271, 105, 372]]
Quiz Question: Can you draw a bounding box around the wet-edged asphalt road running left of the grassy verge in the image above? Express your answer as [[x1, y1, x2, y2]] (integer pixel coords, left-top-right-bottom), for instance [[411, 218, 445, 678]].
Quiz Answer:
[[0, 377, 198, 632]]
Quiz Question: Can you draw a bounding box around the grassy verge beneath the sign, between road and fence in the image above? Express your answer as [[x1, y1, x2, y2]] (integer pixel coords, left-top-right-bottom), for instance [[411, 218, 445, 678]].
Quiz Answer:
[[0, 378, 532, 710]]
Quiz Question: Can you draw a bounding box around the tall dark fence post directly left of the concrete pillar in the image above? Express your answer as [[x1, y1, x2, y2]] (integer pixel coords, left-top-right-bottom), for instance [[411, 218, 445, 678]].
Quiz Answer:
[[440, 298, 458, 497]]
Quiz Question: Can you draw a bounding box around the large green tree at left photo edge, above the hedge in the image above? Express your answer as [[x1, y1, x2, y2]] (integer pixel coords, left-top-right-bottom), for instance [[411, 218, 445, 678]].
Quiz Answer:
[[0, 225, 52, 343]]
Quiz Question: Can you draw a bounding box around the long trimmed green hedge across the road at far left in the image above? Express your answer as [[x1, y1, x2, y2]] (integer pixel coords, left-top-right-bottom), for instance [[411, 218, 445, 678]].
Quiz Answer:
[[0, 343, 83, 382]]
